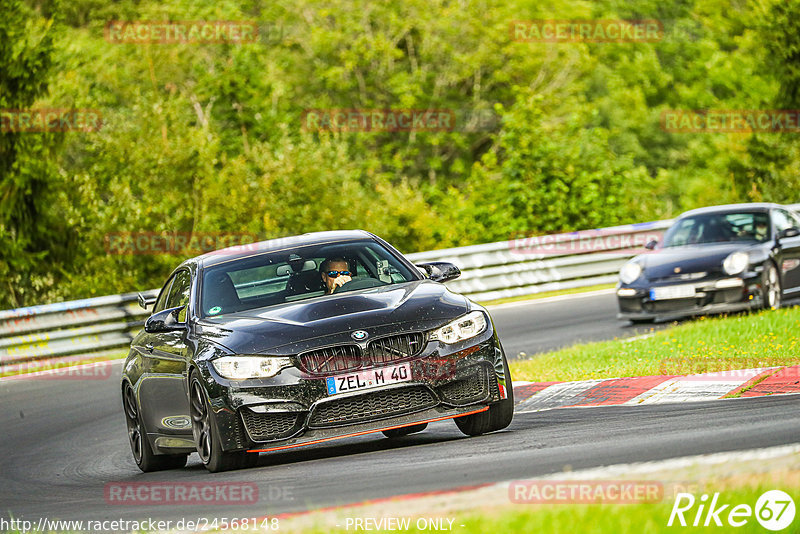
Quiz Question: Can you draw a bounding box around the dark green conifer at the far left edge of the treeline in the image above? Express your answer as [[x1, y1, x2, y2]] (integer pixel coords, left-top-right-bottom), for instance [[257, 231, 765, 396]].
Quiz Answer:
[[0, 0, 71, 306]]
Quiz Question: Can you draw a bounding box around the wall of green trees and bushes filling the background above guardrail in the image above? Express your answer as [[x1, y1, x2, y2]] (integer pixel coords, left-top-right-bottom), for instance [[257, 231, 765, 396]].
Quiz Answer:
[[0, 0, 800, 308]]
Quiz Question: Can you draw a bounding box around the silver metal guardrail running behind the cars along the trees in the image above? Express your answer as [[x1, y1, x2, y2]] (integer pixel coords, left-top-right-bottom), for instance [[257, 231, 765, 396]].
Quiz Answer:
[[0, 204, 800, 372]]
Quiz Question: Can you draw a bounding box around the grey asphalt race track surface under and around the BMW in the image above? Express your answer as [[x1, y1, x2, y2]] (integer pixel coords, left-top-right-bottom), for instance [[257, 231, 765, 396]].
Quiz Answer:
[[0, 295, 800, 521]]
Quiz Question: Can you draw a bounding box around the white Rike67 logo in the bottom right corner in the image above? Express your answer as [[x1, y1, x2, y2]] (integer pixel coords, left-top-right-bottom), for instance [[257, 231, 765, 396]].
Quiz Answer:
[[667, 490, 795, 532]]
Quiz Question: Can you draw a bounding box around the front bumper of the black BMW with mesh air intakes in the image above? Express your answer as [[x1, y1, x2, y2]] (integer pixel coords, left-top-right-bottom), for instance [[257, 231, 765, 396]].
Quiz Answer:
[[203, 333, 510, 451]]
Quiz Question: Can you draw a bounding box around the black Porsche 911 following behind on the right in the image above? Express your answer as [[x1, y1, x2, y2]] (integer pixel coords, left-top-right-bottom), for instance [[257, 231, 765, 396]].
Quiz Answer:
[[617, 203, 800, 323]]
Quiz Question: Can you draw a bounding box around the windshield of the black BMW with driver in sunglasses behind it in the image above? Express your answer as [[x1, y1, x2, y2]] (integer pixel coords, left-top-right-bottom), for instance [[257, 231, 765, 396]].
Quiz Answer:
[[200, 240, 419, 317]]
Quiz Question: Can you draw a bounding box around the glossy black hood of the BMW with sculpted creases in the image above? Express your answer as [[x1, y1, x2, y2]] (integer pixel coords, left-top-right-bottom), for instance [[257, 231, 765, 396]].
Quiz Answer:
[[198, 280, 470, 355]]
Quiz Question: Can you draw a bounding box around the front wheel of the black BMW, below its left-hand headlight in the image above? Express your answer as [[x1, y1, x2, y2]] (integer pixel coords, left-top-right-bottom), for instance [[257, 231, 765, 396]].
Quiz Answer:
[[189, 371, 253, 473]]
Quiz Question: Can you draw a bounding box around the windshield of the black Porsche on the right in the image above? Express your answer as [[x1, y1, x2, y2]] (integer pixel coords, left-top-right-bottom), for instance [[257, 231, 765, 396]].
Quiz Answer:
[[664, 212, 770, 247]]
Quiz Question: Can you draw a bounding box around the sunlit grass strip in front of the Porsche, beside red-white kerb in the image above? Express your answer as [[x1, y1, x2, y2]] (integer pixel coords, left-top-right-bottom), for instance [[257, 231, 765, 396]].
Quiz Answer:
[[511, 307, 800, 382]]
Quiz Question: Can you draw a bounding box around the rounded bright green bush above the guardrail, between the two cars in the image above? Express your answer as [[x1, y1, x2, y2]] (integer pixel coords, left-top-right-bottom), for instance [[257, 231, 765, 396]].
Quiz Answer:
[[462, 98, 653, 244]]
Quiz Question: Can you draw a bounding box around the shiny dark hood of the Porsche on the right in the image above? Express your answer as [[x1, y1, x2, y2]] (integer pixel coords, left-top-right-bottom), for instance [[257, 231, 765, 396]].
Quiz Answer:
[[637, 243, 758, 279]]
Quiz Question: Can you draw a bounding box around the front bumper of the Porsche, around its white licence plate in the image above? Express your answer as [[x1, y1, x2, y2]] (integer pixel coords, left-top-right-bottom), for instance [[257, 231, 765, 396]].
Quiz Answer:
[[617, 275, 763, 321]]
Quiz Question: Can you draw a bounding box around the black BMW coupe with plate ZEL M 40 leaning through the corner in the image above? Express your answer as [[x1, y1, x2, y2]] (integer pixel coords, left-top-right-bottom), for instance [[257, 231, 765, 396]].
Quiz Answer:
[[122, 231, 514, 472]]
